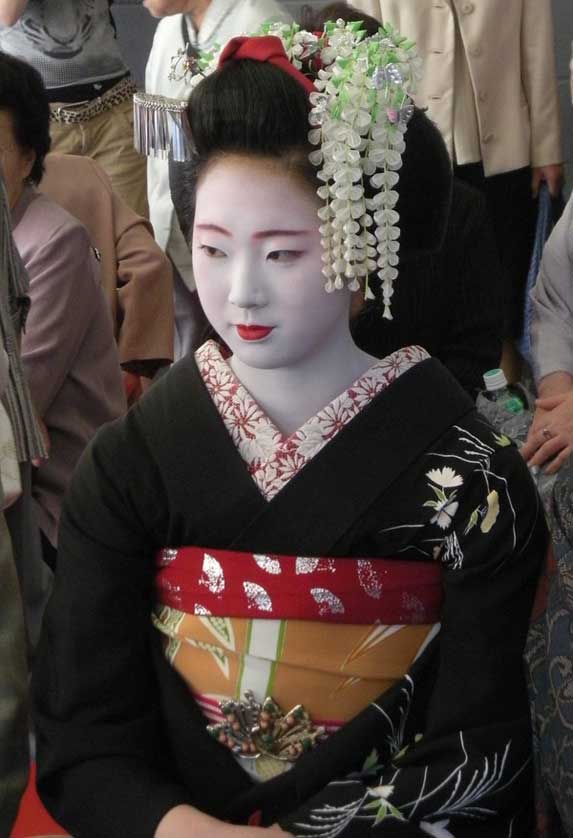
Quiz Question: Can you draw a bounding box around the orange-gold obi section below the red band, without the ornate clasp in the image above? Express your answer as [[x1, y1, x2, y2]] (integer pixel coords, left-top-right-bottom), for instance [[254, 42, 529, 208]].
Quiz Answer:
[[153, 606, 435, 731]]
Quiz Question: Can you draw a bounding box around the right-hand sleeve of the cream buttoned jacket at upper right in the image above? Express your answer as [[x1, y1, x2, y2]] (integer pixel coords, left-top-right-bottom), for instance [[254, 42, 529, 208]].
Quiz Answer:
[[521, 0, 563, 166]]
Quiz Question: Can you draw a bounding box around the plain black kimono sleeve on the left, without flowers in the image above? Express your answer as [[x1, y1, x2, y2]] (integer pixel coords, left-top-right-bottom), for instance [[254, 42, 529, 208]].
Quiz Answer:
[[33, 411, 187, 838]]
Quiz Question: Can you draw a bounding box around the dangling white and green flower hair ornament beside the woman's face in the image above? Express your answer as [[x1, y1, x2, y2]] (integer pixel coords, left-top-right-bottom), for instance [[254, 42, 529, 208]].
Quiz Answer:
[[308, 21, 419, 319]]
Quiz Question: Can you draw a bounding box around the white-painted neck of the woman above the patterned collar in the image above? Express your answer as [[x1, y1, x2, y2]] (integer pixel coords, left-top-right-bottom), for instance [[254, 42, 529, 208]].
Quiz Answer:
[[230, 331, 377, 436]]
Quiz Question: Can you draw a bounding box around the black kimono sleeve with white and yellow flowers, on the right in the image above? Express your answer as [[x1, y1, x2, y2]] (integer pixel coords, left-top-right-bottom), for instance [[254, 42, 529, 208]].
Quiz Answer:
[[281, 440, 547, 838]]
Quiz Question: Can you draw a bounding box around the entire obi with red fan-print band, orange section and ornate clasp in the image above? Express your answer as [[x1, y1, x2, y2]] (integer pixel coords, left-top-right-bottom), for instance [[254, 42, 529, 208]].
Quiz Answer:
[[153, 547, 441, 779]]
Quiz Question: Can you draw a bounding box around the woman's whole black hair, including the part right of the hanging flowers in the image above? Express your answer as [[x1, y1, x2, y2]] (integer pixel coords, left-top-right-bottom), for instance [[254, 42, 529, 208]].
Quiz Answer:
[[170, 46, 452, 261]]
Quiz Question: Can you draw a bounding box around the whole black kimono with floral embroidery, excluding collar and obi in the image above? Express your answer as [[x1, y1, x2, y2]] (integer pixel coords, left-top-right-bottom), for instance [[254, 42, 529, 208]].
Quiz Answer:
[[34, 344, 546, 838]]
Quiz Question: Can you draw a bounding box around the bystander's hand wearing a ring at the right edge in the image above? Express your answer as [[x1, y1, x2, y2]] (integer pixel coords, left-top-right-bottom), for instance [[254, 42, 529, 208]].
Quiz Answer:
[[521, 391, 573, 474]]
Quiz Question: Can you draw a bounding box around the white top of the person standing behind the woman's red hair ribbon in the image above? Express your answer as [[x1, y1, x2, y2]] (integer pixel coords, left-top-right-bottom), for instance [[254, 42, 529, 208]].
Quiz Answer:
[[145, 0, 291, 289]]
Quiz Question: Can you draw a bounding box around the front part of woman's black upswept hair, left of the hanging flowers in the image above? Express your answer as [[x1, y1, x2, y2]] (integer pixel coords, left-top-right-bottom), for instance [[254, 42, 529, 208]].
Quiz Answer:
[[169, 59, 319, 240]]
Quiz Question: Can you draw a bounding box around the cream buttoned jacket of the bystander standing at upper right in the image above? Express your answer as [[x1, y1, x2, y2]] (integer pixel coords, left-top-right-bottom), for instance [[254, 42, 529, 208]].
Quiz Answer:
[[351, 0, 563, 175]]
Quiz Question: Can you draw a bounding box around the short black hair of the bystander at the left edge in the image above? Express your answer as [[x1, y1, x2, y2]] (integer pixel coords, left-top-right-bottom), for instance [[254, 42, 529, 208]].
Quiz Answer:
[[0, 52, 51, 184]]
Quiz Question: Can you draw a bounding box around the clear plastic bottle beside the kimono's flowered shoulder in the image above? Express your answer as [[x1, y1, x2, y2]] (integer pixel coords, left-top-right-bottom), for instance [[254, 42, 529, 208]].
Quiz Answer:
[[477, 369, 533, 445]]
